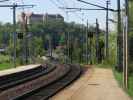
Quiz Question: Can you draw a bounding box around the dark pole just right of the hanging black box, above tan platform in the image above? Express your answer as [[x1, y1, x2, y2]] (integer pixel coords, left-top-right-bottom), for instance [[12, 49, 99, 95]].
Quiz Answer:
[[96, 19, 99, 62]]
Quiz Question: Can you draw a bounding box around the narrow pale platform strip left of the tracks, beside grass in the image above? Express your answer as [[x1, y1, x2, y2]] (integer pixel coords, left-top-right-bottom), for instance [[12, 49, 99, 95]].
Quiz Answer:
[[0, 64, 40, 77]]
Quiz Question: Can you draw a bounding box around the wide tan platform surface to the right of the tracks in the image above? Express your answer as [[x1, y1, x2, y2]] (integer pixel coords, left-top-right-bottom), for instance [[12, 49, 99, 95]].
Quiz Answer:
[[50, 68, 131, 100]]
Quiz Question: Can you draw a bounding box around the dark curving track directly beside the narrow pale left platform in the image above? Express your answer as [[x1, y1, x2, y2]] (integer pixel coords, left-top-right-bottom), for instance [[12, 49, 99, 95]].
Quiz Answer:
[[0, 63, 55, 92]]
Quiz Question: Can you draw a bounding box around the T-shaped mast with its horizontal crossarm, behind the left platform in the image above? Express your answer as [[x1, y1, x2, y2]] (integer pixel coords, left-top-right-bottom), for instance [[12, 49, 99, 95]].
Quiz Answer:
[[0, 3, 35, 67]]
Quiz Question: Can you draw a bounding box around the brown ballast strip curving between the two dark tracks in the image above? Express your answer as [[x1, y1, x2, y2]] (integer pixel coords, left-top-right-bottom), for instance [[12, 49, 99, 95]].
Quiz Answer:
[[0, 63, 69, 100]]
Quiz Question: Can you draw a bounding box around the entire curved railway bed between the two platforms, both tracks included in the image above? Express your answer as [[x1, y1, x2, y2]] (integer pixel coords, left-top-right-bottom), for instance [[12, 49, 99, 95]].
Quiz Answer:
[[0, 62, 81, 100]]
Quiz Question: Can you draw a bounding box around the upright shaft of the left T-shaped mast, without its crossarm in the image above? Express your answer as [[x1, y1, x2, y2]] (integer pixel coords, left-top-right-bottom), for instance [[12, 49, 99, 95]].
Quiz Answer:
[[13, 4, 16, 67]]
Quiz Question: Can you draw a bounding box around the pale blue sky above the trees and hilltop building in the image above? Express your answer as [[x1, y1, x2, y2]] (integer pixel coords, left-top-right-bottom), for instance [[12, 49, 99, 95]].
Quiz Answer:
[[0, 0, 124, 30]]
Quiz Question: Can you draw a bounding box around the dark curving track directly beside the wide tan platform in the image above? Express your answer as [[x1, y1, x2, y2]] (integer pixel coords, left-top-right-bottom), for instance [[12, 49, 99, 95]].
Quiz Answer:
[[16, 65, 81, 100]]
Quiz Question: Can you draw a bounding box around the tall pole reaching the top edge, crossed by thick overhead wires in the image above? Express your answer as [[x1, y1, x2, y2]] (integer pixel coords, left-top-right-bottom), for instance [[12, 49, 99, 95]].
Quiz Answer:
[[105, 1, 109, 59]]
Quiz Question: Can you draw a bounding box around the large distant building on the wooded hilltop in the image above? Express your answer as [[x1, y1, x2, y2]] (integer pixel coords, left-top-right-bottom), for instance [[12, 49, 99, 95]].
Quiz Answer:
[[18, 13, 64, 24]]
